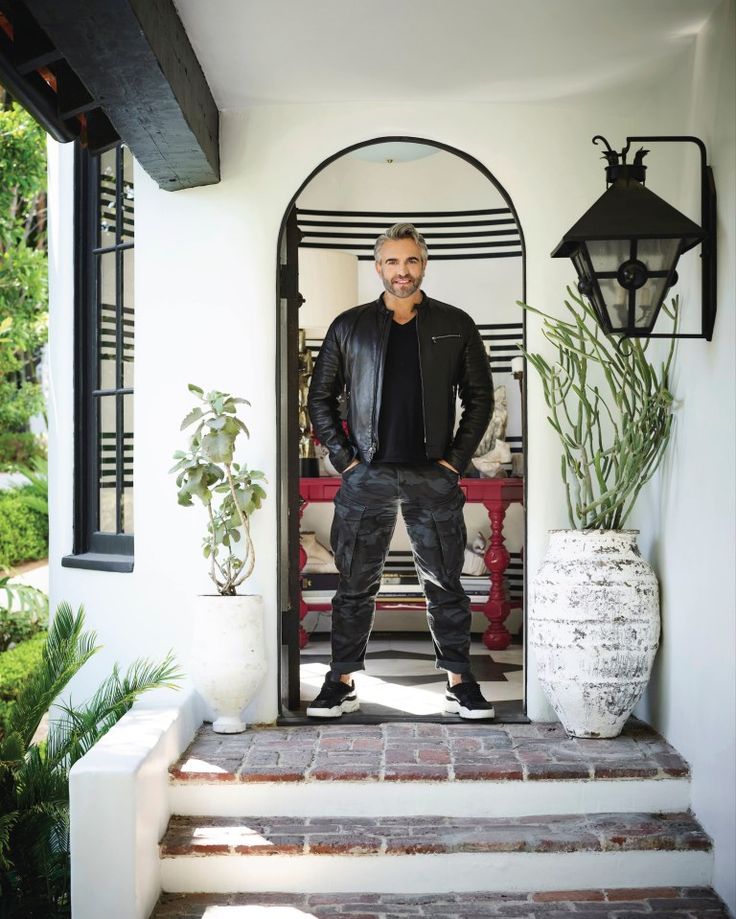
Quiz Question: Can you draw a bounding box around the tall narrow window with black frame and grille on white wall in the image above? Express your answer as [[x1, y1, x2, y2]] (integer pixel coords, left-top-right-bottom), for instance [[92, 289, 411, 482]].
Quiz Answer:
[[62, 144, 135, 571]]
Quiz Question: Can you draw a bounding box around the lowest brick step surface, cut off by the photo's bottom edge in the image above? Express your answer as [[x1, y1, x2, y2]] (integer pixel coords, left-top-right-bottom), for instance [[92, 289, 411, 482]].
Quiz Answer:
[[151, 886, 728, 919]]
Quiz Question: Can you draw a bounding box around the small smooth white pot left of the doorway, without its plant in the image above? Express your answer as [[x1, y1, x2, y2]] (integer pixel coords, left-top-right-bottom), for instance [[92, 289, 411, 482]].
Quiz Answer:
[[192, 594, 268, 734]]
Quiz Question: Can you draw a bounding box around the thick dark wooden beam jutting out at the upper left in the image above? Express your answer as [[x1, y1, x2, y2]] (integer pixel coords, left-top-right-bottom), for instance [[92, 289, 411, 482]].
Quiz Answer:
[[25, 0, 220, 191]]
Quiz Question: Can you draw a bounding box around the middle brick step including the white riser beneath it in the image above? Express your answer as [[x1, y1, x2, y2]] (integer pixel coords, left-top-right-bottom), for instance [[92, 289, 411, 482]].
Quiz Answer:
[[160, 812, 712, 893]]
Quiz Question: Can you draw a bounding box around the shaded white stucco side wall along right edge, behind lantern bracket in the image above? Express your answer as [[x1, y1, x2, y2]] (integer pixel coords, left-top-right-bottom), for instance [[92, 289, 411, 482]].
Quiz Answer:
[[635, 2, 736, 912]]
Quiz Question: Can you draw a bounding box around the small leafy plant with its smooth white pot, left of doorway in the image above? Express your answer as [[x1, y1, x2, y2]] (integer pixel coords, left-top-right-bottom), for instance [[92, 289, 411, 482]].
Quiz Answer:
[[169, 383, 266, 734]]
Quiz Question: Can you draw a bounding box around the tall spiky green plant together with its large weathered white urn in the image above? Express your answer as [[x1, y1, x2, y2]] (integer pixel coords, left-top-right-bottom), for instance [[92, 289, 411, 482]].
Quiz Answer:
[[519, 288, 678, 737]]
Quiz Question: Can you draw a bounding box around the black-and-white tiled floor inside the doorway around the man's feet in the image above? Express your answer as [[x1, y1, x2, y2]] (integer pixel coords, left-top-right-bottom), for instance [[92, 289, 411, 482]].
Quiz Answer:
[[301, 635, 523, 715]]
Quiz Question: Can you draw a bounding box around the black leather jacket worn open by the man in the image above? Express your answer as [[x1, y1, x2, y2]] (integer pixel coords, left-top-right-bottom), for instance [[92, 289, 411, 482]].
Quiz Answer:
[[307, 294, 493, 473]]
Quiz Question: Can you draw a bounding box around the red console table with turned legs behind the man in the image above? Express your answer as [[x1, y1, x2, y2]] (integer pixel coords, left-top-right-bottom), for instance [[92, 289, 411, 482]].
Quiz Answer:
[[299, 476, 524, 651]]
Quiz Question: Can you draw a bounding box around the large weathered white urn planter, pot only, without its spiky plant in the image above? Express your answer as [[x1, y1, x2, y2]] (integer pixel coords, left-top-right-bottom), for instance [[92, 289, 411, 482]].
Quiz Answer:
[[529, 530, 659, 737]]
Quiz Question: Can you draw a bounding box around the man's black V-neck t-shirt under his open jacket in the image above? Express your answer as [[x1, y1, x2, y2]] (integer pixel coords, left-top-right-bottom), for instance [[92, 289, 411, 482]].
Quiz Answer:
[[374, 316, 427, 463]]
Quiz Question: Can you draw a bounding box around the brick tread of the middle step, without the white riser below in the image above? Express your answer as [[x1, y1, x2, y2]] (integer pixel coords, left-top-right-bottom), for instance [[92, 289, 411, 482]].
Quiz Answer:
[[160, 812, 711, 858]]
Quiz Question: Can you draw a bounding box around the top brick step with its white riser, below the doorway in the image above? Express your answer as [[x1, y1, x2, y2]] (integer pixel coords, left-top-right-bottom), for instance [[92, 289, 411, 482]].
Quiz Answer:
[[169, 718, 690, 817]]
